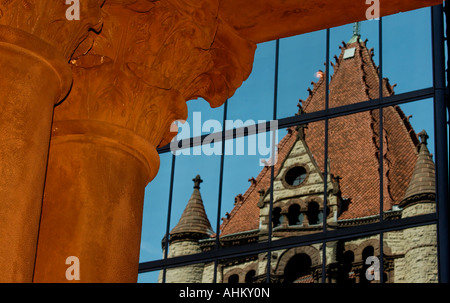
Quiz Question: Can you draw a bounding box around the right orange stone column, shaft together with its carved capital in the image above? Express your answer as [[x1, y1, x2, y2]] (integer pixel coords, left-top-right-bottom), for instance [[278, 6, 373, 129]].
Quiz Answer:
[[34, 0, 256, 282]]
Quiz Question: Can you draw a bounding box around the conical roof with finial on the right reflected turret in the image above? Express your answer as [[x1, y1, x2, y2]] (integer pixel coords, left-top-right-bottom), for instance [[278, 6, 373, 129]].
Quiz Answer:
[[404, 130, 436, 200]]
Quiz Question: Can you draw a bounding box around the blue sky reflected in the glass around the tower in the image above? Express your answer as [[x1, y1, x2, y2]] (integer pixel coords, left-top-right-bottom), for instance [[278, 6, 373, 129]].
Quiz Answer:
[[139, 8, 434, 282]]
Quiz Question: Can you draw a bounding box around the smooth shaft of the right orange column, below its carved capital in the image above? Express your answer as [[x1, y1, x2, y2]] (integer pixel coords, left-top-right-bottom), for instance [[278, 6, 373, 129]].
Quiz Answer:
[[34, 121, 159, 282]]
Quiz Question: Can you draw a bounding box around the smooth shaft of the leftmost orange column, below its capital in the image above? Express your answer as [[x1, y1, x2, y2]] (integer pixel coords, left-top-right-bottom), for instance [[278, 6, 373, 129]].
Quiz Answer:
[[0, 25, 72, 282]]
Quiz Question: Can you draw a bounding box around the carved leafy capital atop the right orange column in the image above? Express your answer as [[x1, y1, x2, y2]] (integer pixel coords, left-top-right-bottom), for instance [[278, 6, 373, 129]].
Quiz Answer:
[[54, 0, 256, 153]]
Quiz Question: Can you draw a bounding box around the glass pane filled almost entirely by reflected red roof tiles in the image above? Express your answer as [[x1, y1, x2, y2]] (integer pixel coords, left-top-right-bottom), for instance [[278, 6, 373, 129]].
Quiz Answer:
[[328, 110, 380, 228]]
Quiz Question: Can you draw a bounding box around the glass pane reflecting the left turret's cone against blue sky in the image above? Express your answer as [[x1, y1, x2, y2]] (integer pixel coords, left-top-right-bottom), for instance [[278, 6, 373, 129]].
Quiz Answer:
[[168, 146, 222, 258]]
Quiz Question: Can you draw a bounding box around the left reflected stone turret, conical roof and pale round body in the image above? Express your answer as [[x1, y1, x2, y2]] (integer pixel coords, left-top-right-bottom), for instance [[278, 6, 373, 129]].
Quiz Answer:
[[160, 175, 213, 283]]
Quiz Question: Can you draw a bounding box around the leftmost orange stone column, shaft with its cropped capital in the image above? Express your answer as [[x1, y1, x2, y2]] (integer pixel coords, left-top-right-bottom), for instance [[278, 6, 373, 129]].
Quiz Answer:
[[0, 0, 104, 282]]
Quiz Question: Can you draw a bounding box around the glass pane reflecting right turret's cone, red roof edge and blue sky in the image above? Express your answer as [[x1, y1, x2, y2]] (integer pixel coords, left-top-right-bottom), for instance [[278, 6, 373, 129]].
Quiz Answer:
[[383, 99, 436, 220]]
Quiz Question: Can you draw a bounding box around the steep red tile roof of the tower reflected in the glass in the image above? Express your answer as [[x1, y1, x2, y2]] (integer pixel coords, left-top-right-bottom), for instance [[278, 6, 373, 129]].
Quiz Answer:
[[221, 38, 419, 235]]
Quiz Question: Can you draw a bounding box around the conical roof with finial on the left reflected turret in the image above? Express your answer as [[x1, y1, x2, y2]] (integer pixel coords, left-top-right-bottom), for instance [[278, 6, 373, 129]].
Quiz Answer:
[[170, 175, 213, 236]]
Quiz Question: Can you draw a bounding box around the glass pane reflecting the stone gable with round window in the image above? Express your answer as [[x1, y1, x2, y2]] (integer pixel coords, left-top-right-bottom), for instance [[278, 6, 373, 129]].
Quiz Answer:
[[268, 121, 326, 240]]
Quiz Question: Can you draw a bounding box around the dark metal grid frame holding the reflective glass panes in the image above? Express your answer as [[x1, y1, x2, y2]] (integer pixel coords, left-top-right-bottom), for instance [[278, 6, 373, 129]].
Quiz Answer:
[[139, 3, 450, 283]]
